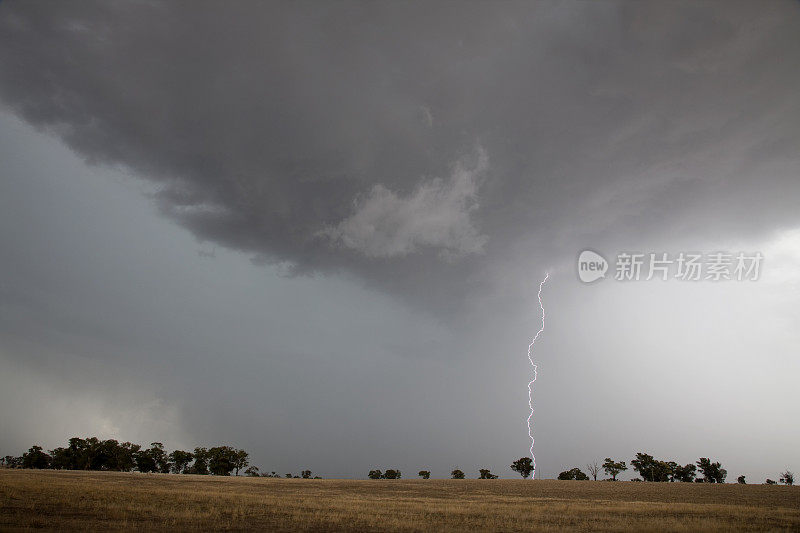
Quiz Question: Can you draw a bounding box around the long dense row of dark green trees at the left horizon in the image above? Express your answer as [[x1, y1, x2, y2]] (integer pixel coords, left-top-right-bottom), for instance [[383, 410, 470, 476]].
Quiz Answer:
[[0, 437, 318, 478]]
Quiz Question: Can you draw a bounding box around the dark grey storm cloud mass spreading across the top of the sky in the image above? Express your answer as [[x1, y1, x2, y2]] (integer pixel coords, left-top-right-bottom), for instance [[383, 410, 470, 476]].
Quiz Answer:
[[0, 2, 800, 306]]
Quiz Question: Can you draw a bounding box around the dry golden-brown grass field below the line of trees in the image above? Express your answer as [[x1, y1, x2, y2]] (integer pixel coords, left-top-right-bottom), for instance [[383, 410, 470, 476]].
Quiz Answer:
[[0, 469, 800, 531]]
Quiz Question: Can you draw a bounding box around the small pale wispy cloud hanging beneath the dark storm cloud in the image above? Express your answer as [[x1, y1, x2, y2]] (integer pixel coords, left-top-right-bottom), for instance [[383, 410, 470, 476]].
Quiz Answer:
[[322, 148, 489, 259]]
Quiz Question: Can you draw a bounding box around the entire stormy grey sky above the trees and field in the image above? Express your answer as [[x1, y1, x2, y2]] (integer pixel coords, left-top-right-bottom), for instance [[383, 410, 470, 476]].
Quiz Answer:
[[0, 1, 800, 481]]
